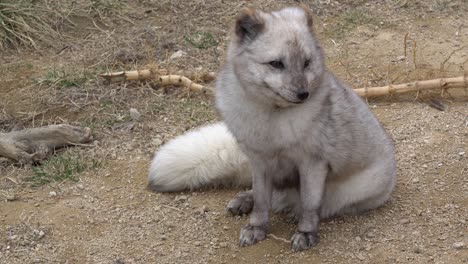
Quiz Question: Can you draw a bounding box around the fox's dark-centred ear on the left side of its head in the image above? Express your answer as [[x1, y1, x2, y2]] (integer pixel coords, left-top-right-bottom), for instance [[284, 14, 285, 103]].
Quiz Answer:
[[236, 8, 265, 42]]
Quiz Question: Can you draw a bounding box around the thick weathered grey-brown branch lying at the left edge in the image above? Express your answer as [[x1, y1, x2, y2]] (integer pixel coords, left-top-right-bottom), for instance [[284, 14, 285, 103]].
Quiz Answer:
[[0, 125, 93, 164]]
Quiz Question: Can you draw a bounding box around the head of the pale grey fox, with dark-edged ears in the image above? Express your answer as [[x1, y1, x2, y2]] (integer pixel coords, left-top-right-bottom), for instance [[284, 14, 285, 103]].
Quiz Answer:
[[227, 7, 325, 107]]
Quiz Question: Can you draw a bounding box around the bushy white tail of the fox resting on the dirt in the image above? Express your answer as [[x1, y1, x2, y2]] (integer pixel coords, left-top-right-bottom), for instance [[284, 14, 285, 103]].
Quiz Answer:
[[148, 122, 252, 192]]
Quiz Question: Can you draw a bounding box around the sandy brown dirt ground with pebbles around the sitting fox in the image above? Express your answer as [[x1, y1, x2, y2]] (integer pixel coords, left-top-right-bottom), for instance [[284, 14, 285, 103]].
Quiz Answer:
[[0, 0, 468, 264]]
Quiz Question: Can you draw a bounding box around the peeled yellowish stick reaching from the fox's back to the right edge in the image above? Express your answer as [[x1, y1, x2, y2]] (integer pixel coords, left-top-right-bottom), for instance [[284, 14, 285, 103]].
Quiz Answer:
[[354, 76, 468, 98]]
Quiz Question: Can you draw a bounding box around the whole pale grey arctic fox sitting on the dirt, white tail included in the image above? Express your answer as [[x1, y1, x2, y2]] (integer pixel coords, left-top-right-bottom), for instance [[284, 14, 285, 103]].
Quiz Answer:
[[149, 7, 396, 251]]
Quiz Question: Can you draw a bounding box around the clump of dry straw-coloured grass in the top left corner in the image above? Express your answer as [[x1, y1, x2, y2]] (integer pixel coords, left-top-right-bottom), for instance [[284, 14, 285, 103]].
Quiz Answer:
[[0, 0, 130, 50]]
